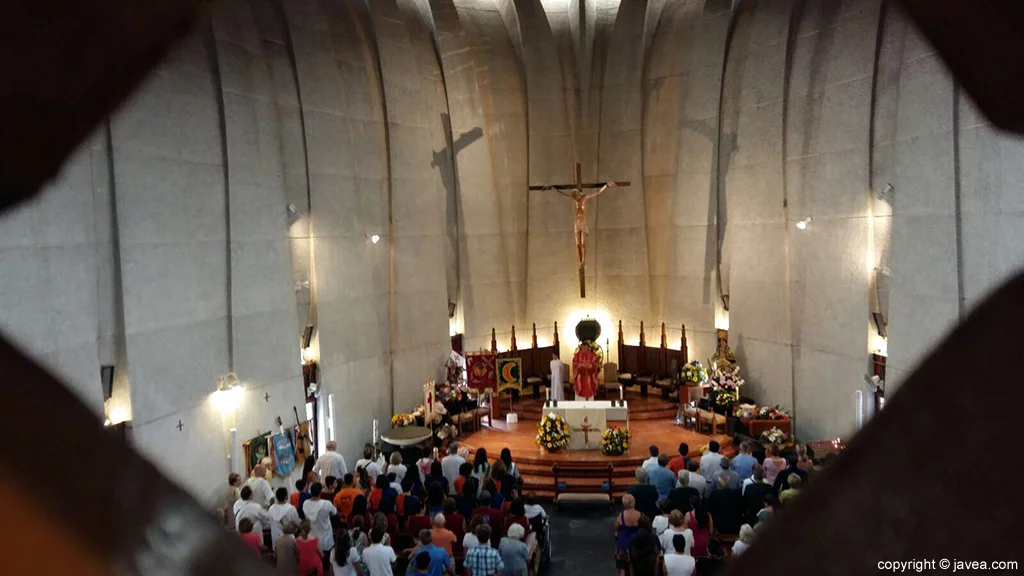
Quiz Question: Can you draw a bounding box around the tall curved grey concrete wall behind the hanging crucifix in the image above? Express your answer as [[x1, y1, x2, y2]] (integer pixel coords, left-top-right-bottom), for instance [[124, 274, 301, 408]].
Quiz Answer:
[[9, 0, 1024, 495]]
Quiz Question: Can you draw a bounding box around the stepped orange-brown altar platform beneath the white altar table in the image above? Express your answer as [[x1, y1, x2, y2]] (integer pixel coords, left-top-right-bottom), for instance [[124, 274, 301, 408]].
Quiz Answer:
[[459, 414, 736, 500]]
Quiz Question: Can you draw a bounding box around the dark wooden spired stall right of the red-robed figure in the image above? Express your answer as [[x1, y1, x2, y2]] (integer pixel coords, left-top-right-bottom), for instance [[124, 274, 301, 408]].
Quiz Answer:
[[617, 320, 689, 398]]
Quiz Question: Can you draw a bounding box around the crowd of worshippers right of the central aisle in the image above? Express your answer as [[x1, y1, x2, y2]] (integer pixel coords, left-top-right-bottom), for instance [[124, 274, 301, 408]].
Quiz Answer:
[[615, 441, 813, 576]]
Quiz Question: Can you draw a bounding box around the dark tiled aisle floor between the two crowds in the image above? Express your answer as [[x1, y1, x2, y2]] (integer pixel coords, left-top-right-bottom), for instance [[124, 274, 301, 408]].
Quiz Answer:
[[542, 505, 615, 576]]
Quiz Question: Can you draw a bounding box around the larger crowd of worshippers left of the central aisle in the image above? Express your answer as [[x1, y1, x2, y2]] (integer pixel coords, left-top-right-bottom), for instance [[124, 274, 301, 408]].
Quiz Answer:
[[217, 442, 546, 576]]
